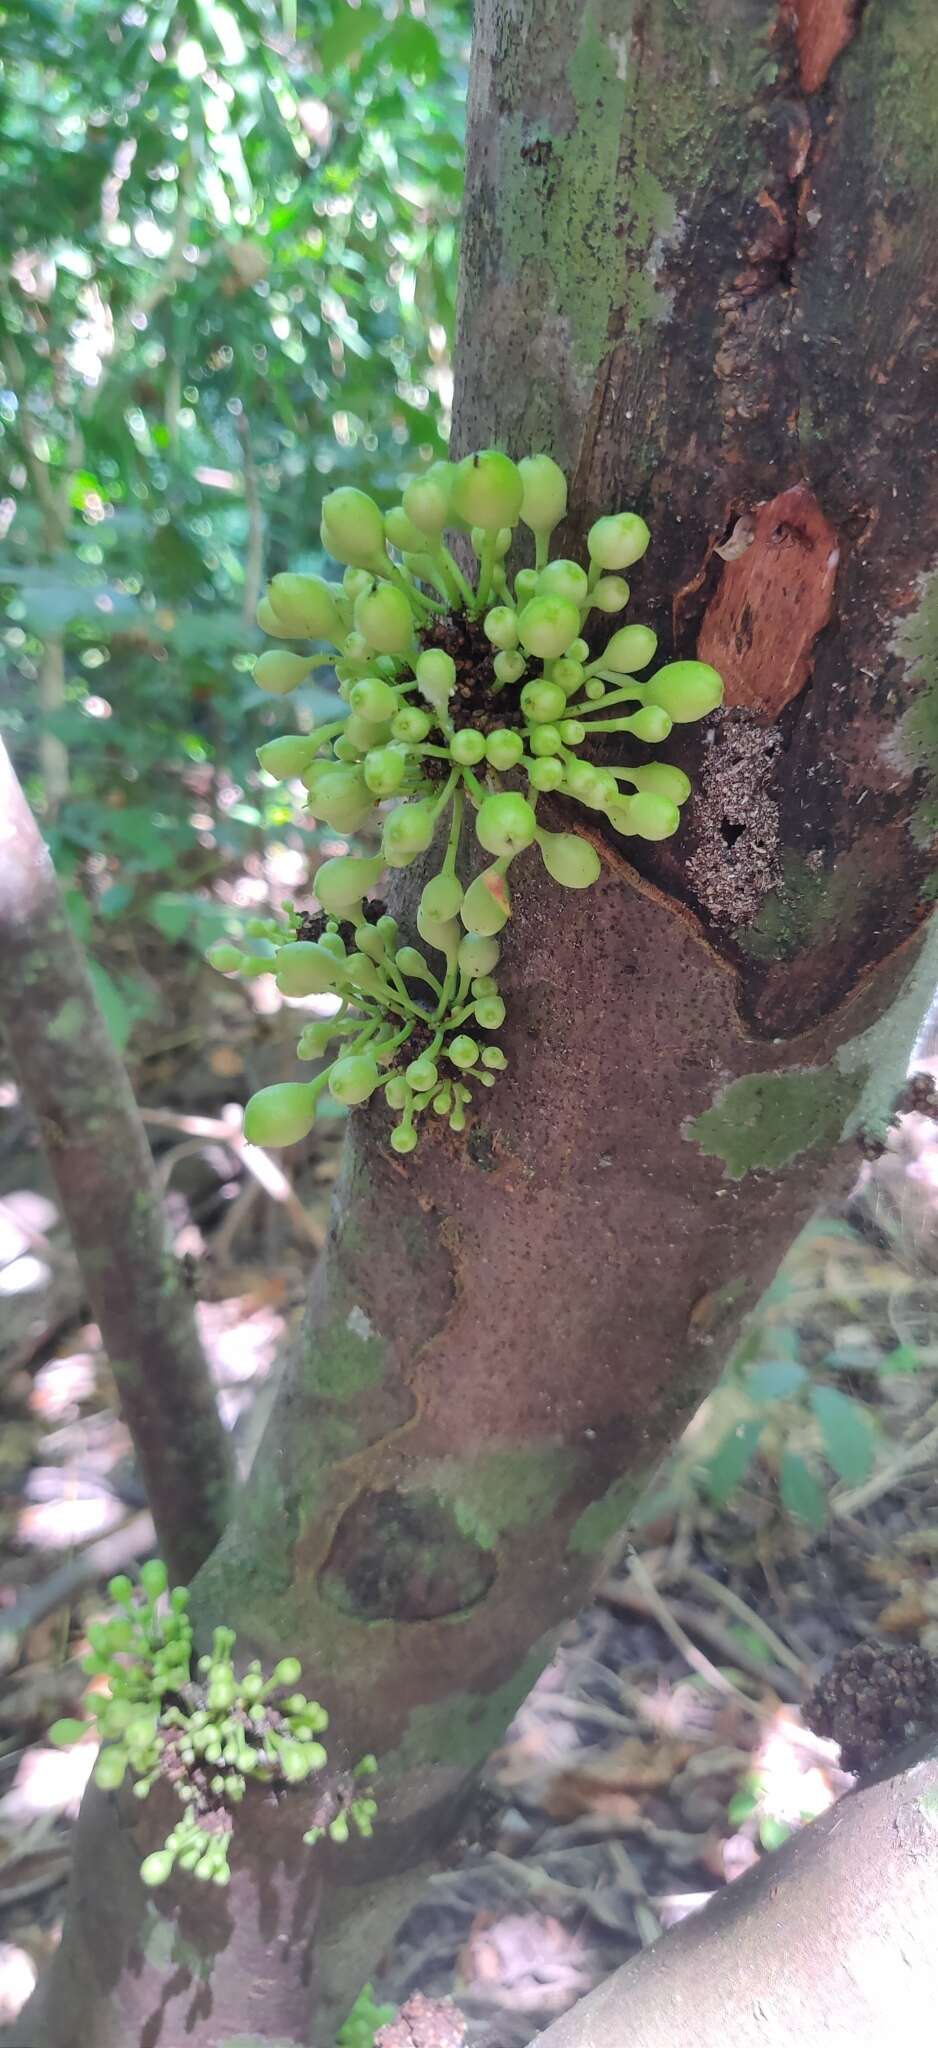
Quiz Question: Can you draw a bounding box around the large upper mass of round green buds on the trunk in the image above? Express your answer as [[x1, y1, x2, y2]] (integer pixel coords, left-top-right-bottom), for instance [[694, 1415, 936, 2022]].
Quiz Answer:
[[211, 449, 723, 1151]]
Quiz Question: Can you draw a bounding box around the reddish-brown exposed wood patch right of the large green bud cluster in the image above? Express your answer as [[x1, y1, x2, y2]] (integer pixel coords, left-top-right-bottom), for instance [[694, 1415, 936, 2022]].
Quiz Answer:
[[698, 483, 840, 719]]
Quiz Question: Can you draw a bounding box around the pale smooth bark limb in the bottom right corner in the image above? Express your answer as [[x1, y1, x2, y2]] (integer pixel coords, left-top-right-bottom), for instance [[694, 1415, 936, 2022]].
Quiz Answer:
[[537, 1759, 938, 2048]]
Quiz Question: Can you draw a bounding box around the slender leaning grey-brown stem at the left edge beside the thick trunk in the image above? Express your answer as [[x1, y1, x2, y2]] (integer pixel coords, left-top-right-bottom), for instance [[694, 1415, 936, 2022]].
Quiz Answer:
[[0, 743, 231, 1583]]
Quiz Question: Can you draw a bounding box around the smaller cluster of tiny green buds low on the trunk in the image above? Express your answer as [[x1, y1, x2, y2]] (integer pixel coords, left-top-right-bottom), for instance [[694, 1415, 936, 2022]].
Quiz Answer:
[[49, 1559, 377, 1884]]
